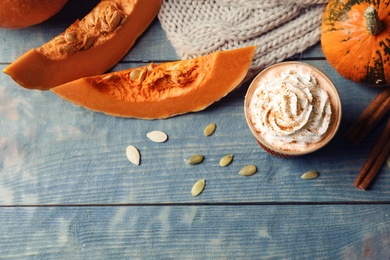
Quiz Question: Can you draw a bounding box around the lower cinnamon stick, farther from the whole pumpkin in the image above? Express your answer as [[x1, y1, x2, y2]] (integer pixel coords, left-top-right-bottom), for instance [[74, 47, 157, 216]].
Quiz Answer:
[[354, 119, 390, 190]]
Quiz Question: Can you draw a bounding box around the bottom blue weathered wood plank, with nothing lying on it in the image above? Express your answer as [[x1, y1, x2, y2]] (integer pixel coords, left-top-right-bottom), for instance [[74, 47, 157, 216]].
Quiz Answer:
[[0, 205, 390, 259]]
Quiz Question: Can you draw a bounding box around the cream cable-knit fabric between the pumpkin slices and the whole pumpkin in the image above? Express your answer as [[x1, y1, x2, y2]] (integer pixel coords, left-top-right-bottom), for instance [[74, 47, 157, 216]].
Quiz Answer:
[[158, 0, 328, 78]]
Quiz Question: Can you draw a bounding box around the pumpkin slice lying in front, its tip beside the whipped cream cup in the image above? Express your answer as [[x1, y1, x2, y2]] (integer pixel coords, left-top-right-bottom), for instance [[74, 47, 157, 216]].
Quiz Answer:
[[51, 46, 256, 119]]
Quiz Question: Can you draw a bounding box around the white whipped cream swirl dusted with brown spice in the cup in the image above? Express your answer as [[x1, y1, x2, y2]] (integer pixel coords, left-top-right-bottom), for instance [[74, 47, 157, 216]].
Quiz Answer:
[[250, 70, 332, 150]]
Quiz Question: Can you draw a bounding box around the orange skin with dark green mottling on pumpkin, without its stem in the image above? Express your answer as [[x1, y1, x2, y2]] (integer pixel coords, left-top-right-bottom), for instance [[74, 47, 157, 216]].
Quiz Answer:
[[321, 0, 390, 87]]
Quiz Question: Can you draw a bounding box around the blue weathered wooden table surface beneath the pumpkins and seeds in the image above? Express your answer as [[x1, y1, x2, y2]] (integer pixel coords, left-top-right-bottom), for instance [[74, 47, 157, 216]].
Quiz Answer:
[[0, 1, 390, 259]]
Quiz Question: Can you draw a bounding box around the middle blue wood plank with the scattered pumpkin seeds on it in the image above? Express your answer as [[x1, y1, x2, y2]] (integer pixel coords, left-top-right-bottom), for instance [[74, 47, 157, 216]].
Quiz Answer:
[[0, 61, 390, 205]]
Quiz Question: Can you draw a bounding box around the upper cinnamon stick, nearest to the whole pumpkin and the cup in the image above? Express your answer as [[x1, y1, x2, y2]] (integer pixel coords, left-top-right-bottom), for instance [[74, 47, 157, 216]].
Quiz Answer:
[[345, 88, 390, 144]]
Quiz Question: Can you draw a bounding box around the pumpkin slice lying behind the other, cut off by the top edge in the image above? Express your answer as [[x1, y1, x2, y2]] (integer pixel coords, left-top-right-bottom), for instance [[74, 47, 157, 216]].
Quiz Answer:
[[3, 0, 161, 90]]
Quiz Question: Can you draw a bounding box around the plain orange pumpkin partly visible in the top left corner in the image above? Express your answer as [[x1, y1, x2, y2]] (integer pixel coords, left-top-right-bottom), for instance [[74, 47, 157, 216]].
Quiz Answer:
[[0, 0, 67, 28]]
